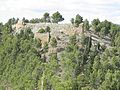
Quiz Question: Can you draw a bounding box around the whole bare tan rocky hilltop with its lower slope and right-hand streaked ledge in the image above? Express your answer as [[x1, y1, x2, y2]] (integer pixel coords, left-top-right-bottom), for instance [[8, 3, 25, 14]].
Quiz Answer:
[[13, 21, 111, 62]]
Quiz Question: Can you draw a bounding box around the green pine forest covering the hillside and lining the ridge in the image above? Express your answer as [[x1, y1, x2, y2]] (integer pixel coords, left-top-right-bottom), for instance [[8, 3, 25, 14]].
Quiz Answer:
[[0, 12, 120, 90]]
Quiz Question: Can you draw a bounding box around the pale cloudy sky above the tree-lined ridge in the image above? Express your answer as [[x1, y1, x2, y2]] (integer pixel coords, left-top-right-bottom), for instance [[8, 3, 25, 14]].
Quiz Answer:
[[0, 0, 120, 24]]
